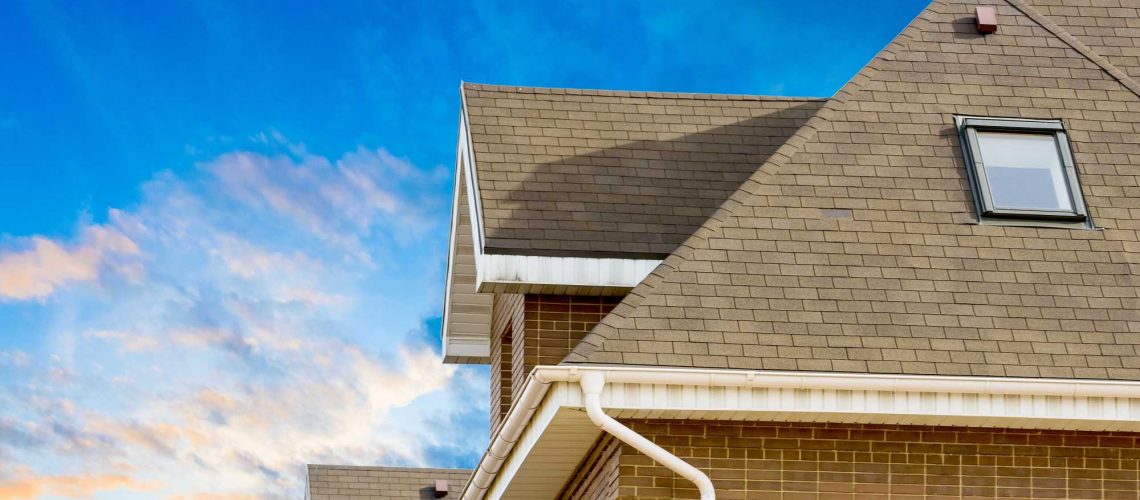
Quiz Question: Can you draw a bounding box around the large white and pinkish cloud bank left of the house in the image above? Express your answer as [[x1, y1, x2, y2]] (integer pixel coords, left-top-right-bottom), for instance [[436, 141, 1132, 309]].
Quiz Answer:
[[0, 146, 487, 499]]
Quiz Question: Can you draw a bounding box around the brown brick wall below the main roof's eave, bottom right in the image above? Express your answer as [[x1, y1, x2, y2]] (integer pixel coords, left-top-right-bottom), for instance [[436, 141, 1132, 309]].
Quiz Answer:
[[567, 420, 1140, 500]]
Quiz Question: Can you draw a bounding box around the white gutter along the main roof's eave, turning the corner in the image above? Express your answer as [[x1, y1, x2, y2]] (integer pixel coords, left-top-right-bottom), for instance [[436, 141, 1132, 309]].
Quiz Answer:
[[462, 364, 1140, 500]]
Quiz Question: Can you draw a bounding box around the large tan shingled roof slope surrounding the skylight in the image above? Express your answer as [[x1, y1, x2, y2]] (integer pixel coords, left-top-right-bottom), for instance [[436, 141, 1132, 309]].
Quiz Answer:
[[565, 0, 1140, 380]]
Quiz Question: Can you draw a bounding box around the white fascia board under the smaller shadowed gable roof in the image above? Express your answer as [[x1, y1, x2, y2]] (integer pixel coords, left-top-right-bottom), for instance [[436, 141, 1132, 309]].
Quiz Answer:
[[475, 254, 661, 290]]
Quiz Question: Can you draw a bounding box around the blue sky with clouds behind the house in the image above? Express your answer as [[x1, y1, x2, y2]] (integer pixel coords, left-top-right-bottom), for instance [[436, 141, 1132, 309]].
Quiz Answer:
[[0, 0, 926, 500]]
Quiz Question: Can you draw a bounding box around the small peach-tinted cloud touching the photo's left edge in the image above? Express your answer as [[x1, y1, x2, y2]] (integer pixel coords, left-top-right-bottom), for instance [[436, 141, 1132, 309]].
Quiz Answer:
[[0, 226, 139, 300]]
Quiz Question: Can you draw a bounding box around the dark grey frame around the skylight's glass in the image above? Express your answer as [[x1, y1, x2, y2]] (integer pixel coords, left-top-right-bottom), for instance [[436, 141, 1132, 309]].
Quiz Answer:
[[954, 116, 1089, 227]]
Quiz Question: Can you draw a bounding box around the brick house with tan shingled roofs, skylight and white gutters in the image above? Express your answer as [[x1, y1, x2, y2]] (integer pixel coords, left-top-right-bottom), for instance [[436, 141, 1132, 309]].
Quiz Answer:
[[312, 0, 1140, 499]]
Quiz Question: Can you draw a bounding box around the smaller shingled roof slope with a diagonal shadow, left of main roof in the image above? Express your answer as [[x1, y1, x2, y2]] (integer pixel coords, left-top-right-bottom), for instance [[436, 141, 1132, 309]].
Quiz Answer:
[[463, 83, 825, 257]]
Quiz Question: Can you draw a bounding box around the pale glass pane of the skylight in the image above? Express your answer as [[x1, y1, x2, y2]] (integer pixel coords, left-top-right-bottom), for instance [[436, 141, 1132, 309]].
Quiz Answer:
[[978, 131, 1073, 211]]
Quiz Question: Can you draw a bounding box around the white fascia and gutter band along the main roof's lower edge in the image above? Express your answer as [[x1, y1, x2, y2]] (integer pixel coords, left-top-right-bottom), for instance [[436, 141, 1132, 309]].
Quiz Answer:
[[463, 364, 1140, 499]]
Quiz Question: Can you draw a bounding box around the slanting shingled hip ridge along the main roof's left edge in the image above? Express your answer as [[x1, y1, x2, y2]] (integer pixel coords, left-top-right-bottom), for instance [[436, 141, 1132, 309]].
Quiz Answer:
[[562, 0, 943, 363]]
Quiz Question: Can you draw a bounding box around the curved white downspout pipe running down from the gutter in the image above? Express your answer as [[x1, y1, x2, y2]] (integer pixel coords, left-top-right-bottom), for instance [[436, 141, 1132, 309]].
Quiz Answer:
[[580, 371, 716, 500]]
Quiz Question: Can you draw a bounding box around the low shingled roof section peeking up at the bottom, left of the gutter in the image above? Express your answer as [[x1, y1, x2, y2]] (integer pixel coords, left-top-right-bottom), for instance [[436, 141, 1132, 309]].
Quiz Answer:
[[307, 464, 471, 500]]
